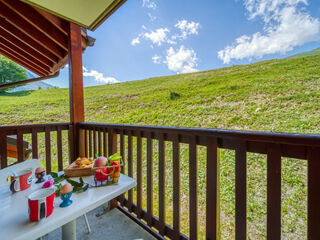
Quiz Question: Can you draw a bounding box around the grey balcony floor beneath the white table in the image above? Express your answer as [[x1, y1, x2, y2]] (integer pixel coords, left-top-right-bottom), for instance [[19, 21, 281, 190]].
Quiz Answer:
[[43, 204, 155, 240]]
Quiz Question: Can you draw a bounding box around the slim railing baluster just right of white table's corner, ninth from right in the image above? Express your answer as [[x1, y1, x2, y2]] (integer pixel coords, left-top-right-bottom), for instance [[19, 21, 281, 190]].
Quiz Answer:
[[137, 131, 142, 218]]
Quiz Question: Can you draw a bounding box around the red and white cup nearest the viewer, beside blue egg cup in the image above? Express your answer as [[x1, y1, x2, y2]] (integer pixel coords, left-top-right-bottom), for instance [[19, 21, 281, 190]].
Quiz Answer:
[[28, 188, 55, 222]]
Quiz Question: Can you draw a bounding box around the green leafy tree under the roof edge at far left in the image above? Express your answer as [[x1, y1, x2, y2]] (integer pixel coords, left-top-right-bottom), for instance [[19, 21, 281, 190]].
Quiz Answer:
[[0, 55, 28, 93]]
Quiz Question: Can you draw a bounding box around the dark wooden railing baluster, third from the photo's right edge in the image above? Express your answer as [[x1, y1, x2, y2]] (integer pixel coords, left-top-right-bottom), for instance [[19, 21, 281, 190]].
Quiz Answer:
[[236, 141, 247, 240]]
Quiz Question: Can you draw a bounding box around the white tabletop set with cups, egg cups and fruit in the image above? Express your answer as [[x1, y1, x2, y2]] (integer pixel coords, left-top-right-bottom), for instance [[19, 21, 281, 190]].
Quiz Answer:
[[0, 174, 136, 240]]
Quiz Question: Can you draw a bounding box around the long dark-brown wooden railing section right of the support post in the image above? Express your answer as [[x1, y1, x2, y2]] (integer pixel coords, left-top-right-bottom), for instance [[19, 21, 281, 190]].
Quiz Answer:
[[79, 123, 320, 240]]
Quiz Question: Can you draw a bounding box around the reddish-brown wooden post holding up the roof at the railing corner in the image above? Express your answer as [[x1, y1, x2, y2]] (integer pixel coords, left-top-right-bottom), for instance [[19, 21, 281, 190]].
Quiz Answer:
[[68, 23, 84, 162]]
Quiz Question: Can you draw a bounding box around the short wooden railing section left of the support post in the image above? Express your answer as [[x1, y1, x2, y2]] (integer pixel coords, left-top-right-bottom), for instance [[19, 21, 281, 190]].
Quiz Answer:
[[0, 123, 73, 173]]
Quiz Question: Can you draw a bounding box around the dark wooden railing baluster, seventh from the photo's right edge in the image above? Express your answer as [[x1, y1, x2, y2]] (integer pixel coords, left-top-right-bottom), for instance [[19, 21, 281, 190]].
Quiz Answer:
[[159, 133, 166, 236]]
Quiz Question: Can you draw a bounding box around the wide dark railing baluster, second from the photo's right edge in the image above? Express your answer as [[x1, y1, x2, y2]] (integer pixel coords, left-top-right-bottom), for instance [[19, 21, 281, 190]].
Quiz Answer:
[[267, 144, 281, 240]]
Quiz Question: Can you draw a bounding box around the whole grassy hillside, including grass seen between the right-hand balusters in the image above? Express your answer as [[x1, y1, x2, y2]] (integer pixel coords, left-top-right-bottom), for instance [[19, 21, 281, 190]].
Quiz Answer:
[[0, 55, 320, 239]]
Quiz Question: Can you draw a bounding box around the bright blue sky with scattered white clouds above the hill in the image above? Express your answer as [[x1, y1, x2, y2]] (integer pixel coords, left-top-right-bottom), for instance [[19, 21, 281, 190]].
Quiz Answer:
[[46, 0, 320, 87]]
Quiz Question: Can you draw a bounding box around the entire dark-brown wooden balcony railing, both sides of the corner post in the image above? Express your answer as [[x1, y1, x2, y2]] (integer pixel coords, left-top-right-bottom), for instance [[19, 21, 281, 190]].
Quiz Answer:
[[0, 123, 320, 239]]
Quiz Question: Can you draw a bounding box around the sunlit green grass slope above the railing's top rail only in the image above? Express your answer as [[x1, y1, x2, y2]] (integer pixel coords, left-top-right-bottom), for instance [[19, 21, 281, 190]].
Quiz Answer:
[[0, 55, 320, 133]]
